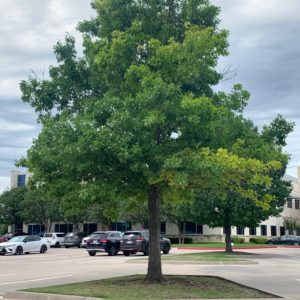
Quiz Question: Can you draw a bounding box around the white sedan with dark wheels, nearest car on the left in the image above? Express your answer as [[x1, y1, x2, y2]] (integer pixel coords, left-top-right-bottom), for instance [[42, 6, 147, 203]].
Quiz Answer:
[[0, 235, 48, 255]]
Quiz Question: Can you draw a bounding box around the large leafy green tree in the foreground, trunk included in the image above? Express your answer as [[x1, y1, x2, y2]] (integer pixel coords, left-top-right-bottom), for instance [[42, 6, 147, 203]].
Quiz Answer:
[[21, 0, 292, 282]]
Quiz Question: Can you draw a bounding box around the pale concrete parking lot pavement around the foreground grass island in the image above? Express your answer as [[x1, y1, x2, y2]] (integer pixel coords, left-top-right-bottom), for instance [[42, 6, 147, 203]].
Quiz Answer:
[[0, 248, 300, 299]]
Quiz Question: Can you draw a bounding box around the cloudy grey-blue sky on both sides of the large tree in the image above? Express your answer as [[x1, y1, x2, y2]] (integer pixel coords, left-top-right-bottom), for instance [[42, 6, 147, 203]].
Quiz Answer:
[[0, 0, 300, 192]]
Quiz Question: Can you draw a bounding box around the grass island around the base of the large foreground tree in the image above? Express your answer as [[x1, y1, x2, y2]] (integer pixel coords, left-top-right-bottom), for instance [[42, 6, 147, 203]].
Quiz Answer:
[[25, 275, 274, 300]]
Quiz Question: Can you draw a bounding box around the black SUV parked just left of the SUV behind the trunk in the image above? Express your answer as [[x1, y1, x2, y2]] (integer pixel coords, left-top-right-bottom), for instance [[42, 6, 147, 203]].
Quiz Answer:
[[86, 231, 123, 256]]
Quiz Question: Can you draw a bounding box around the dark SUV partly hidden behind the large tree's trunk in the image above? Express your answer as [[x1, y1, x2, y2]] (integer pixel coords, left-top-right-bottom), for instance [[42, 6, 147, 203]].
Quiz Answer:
[[121, 230, 171, 256]]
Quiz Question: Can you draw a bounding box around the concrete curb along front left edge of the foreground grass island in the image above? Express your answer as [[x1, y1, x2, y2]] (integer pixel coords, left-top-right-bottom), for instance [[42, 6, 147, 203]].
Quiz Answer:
[[3, 292, 103, 300]]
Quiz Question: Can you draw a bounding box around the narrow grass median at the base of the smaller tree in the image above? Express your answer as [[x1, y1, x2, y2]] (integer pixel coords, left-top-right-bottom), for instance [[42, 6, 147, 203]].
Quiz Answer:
[[161, 251, 253, 262]]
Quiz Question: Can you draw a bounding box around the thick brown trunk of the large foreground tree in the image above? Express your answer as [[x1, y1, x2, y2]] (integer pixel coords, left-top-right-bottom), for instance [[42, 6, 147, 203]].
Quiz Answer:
[[145, 184, 164, 283]]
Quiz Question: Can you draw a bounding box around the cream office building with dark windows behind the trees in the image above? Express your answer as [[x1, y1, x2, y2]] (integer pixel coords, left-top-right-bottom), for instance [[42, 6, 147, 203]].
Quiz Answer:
[[11, 167, 300, 241]]
